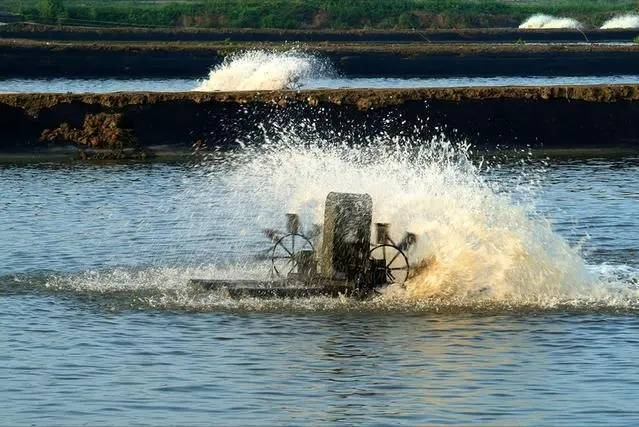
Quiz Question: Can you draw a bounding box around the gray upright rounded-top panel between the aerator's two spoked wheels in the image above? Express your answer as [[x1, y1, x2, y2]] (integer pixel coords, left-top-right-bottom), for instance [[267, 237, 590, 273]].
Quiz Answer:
[[319, 192, 373, 280]]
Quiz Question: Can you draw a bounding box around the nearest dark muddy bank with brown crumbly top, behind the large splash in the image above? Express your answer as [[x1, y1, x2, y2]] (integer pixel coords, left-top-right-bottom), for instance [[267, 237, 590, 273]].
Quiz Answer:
[[0, 85, 639, 158]]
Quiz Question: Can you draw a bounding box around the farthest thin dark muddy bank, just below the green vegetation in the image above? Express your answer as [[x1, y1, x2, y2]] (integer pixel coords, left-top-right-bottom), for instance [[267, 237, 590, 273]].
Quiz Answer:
[[0, 23, 639, 43]]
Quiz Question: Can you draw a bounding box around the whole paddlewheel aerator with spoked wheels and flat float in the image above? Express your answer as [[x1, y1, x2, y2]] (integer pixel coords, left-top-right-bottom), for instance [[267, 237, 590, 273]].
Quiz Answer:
[[191, 192, 416, 298]]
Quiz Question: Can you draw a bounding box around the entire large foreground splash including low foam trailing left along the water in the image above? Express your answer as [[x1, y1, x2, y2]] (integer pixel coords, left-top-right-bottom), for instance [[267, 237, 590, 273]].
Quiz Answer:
[[11, 118, 639, 312]]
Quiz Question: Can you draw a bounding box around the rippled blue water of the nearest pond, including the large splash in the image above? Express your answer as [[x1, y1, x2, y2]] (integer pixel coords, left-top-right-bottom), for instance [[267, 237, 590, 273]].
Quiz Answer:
[[0, 142, 639, 426]]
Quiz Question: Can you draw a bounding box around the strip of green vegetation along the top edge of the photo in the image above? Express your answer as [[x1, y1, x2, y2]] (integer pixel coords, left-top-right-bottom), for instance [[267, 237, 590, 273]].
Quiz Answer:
[[0, 0, 639, 29]]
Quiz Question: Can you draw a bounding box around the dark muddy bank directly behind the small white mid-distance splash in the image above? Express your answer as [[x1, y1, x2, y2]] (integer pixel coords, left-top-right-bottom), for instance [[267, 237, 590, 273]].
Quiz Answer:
[[0, 39, 639, 78]]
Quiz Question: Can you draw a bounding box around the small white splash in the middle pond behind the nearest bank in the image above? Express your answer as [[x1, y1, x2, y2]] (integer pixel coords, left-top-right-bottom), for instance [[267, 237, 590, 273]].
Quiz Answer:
[[195, 49, 333, 92]]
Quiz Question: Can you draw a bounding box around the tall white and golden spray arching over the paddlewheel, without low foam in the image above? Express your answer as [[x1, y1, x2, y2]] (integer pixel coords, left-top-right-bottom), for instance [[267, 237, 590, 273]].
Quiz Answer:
[[218, 123, 608, 301]]
